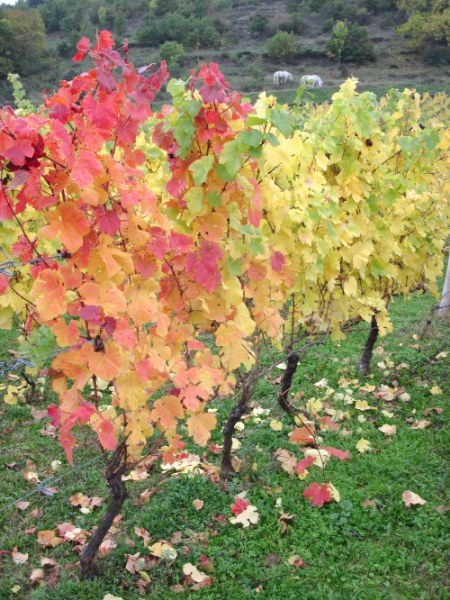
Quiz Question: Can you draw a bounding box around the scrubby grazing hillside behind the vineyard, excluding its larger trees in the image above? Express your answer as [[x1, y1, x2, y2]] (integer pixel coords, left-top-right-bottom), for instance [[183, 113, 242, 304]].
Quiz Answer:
[[0, 0, 450, 103]]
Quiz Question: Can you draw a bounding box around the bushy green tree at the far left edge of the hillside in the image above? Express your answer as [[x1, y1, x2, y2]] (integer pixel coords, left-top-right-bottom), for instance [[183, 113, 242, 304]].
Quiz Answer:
[[0, 8, 46, 75]]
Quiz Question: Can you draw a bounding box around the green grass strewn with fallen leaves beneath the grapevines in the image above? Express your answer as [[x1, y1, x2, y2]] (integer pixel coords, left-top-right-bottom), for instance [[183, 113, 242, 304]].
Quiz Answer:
[[0, 288, 450, 600]]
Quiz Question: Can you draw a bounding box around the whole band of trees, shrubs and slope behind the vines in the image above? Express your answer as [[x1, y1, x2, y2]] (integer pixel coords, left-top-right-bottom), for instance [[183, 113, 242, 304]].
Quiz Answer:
[[0, 0, 450, 103]]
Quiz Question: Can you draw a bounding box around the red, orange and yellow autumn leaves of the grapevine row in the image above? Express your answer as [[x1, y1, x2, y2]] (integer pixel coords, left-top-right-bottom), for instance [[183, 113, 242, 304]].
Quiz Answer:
[[0, 31, 450, 502]]
